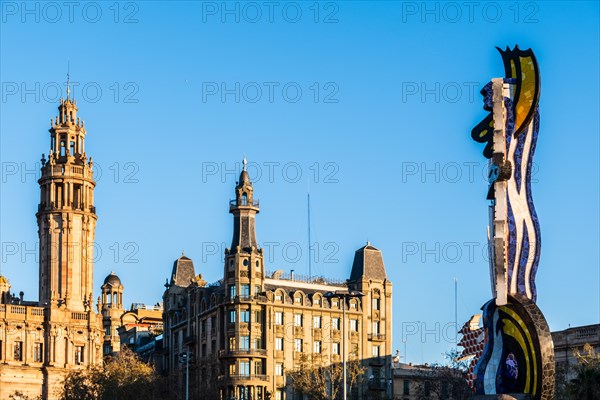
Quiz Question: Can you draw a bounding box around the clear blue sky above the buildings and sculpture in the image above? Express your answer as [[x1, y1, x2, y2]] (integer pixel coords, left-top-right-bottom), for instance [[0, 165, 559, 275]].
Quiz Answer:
[[0, 1, 600, 363]]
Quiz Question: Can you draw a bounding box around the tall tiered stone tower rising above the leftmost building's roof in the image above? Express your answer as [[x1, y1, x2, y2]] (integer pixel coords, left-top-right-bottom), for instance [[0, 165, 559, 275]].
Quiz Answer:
[[36, 84, 97, 311]]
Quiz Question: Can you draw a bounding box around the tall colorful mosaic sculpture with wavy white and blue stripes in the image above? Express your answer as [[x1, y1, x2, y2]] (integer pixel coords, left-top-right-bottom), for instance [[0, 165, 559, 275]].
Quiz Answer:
[[461, 46, 554, 400]]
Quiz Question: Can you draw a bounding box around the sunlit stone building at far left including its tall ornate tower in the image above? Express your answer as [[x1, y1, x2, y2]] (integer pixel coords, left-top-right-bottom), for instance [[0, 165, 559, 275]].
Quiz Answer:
[[0, 93, 104, 400]]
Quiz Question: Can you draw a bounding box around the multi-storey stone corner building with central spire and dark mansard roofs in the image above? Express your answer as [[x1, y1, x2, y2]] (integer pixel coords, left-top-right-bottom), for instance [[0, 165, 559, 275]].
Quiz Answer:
[[163, 164, 392, 400]]
